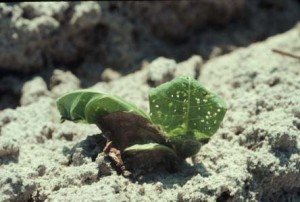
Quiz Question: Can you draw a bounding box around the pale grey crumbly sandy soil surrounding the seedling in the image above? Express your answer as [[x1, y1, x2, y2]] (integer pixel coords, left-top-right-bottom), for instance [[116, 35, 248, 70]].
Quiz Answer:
[[0, 1, 300, 202]]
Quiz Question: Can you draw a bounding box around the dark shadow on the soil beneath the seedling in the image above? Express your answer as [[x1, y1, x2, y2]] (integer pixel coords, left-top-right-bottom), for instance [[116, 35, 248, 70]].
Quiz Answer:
[[63, 134, 209, 189]]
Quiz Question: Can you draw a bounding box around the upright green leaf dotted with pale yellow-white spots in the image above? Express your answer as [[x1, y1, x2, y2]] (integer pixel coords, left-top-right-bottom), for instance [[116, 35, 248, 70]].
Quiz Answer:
[[149, 77, 227, 139]]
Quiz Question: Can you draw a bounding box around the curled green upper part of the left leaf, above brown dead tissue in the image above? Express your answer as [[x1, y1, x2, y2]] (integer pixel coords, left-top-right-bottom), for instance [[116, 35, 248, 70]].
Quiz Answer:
[[56, 90, 149, 123]]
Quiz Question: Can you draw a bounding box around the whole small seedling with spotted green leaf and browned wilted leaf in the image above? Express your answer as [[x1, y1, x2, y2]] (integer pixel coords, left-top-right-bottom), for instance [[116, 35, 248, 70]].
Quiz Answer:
[[57, 77, 227, 174]]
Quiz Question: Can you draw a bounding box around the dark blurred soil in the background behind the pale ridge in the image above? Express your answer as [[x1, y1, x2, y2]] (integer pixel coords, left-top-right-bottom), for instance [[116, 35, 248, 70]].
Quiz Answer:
[[0, 0, 300, 109]]
